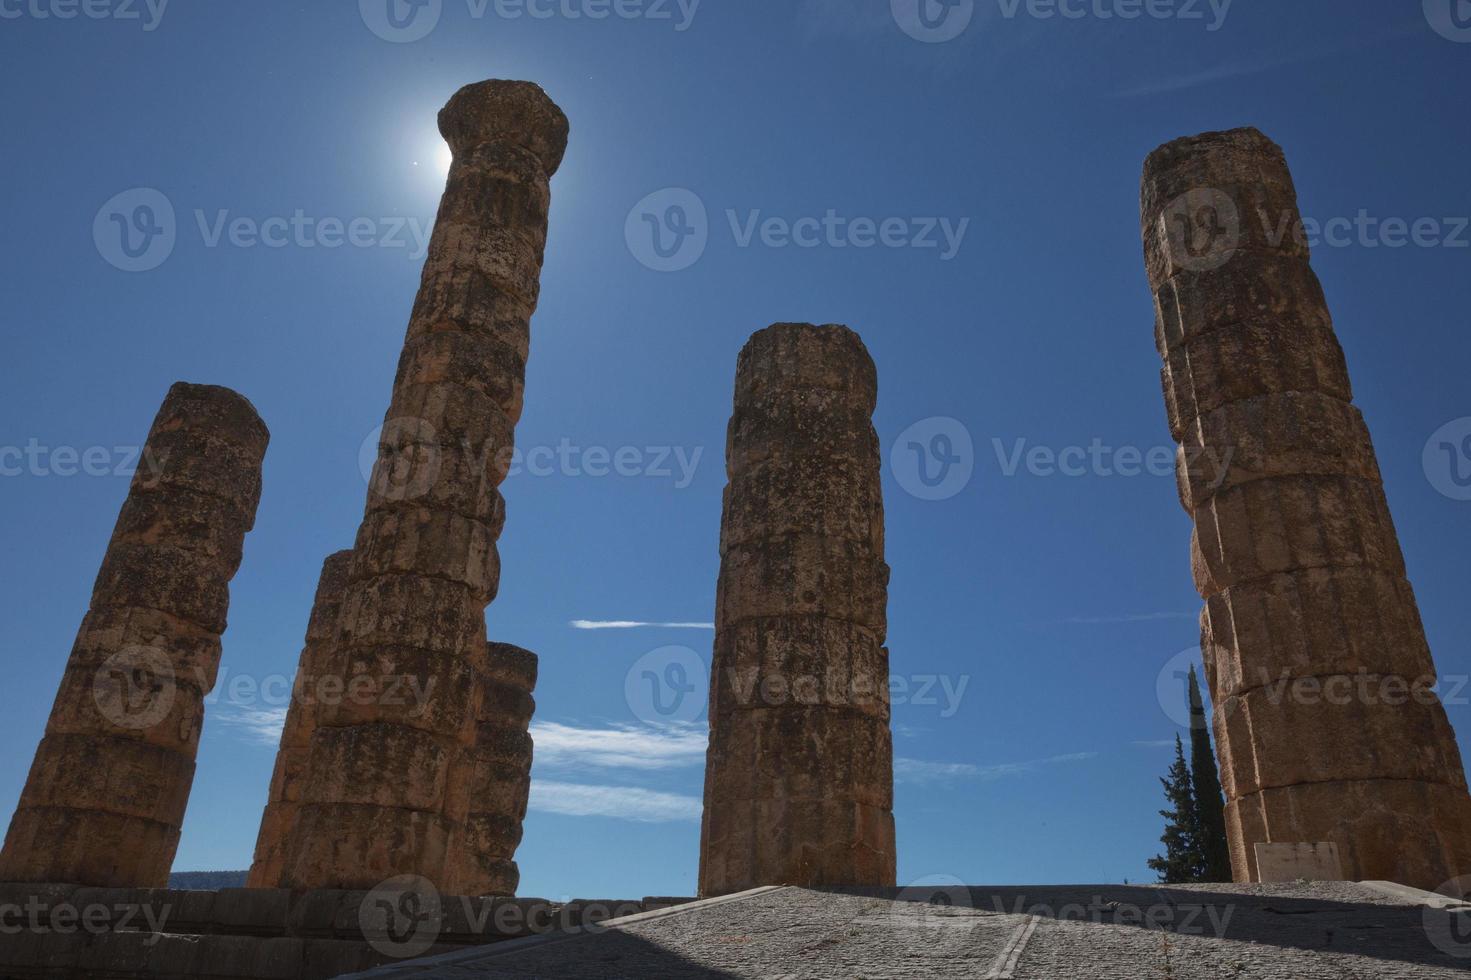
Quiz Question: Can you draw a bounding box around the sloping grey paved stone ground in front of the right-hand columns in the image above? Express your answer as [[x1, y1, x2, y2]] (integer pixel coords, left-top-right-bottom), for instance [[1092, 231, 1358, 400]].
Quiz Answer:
[[344, 881, 1471, 980]]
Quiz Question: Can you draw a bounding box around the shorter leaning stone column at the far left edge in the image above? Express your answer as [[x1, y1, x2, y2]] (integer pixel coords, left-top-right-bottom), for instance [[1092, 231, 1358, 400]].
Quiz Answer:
[[0, 383, 271, 887]]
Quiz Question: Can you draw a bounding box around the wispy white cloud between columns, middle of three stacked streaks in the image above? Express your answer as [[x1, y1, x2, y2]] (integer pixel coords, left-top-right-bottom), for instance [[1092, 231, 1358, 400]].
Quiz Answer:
[[531, 721, 709, 771]]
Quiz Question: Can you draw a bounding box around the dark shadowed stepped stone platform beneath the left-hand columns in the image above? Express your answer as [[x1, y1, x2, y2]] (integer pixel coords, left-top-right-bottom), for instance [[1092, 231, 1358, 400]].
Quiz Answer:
[[0, 884, 690, 980]]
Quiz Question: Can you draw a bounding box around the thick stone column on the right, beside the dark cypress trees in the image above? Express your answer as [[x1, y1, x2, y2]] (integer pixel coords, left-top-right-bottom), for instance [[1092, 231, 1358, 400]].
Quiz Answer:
[[1141, 129, 1471, 889]]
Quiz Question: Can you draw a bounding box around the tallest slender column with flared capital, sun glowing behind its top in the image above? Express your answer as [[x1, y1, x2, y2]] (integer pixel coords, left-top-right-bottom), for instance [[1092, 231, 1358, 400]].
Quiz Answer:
[[282, 81, 568, 887]]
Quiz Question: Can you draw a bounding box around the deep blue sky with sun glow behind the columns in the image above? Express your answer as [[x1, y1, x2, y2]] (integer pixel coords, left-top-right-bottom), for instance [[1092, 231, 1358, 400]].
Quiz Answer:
[[0, 0, 1471, 898]]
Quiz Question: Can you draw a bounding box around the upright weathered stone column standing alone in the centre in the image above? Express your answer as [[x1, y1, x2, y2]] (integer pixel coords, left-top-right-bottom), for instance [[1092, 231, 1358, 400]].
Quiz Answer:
[[700, 324, 894, 895]]
